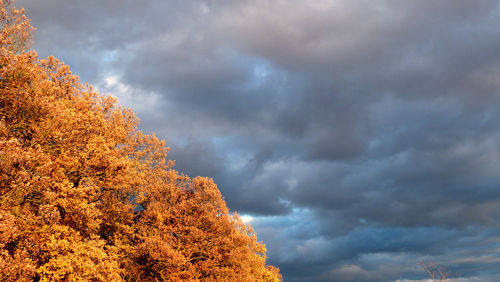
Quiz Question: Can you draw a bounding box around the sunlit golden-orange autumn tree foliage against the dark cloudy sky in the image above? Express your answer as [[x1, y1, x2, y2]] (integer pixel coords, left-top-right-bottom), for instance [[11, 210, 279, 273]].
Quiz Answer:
[[0, 0, 281, 281]]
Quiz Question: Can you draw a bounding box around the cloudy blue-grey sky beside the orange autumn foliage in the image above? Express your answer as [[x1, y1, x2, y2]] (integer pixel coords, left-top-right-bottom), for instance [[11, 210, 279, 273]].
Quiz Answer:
[[16, 0, 500, 281]]
